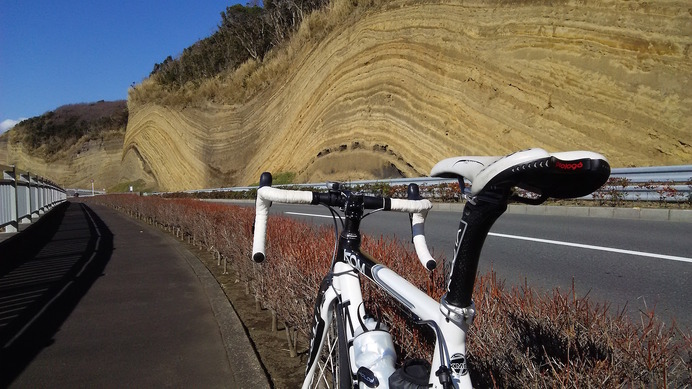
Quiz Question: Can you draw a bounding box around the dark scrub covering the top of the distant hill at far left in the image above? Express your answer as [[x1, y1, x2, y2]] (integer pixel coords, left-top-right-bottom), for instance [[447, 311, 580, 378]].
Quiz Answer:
[[8, 100, 128, 161]]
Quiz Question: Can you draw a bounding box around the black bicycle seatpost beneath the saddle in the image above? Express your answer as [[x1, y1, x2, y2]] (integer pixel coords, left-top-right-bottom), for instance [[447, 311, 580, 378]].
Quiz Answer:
[[445, 195, 507, 308]]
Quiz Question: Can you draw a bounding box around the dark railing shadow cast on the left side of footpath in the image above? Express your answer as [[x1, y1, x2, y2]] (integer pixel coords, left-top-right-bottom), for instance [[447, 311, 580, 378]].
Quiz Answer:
[[0, 202, 113, 387]]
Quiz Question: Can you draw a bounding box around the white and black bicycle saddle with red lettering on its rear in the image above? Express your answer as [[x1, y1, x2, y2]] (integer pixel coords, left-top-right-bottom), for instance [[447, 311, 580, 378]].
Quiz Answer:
[[430, 148, 610, 199]]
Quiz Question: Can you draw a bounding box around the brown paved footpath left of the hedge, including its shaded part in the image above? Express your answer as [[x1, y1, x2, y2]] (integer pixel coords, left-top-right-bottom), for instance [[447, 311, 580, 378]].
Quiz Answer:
[[0, 202, 269, 388]]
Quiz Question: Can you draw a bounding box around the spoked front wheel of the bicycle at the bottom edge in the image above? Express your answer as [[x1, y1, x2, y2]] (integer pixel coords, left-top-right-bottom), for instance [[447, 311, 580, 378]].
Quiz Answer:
[[309, 305, 353, 389]]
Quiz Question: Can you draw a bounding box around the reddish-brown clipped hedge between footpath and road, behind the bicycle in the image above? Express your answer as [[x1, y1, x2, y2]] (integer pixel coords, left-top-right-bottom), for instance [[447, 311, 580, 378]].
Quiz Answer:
[[84, 195, 692, 388]]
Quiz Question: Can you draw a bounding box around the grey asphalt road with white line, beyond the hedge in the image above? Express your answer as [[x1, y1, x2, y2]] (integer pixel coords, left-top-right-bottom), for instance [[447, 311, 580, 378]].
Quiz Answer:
[[272, 204, 692, 330]]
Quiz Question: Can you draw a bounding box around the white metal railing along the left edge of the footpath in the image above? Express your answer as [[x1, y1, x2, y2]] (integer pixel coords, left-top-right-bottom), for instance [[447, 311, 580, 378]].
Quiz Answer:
[[0, 165, 67, 232]]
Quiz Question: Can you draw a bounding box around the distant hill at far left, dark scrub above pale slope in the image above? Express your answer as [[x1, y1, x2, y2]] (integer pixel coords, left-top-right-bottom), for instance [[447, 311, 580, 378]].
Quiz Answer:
[[0, 101, 155, 189]]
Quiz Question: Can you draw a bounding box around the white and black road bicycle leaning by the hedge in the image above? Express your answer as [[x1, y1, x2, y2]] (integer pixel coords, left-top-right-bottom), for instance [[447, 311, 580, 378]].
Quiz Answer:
[[253, 148, 610, 388]]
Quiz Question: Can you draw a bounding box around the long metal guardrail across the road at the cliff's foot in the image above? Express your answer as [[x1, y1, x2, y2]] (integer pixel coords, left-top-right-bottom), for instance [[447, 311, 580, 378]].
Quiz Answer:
[[180, 165, 692, 202]]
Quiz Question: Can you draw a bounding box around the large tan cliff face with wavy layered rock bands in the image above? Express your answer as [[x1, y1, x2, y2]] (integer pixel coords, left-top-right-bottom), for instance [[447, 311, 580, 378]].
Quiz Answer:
[[123, 0, 692, 190]]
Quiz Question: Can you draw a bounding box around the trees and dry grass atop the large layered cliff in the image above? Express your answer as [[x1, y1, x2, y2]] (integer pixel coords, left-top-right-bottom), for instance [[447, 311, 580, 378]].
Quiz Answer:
[[128, 0, 385, 109]]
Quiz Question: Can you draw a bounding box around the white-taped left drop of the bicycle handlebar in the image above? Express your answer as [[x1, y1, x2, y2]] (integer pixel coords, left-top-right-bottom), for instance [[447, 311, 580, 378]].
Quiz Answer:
[[252, 186, 312, 263]]
